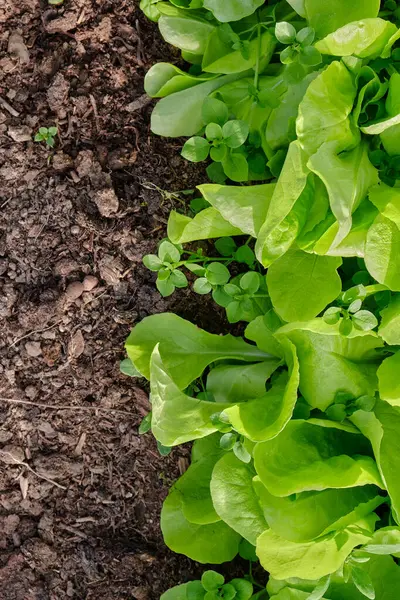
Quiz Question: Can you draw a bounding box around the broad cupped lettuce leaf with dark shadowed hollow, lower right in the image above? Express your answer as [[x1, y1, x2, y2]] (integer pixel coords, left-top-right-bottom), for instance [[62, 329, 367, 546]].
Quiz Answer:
[[254, 419, 382, 496]]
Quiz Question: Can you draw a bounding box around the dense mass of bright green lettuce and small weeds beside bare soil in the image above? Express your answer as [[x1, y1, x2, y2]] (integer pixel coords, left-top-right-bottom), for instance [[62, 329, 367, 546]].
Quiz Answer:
[[123, 0, 400, 600]]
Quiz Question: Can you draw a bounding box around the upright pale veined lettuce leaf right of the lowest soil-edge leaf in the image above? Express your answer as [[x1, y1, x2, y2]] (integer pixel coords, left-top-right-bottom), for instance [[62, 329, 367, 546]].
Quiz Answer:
[[211, 452, 268, 545]]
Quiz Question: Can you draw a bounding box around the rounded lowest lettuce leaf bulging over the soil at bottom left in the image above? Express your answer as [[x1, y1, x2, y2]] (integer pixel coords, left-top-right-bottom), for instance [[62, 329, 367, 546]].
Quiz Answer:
[[161, 490, 241, 564]]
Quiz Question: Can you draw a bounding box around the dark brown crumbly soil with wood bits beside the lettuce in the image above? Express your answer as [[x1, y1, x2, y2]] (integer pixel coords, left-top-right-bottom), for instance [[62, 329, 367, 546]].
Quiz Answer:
[[0, 0, 225, 600]]
